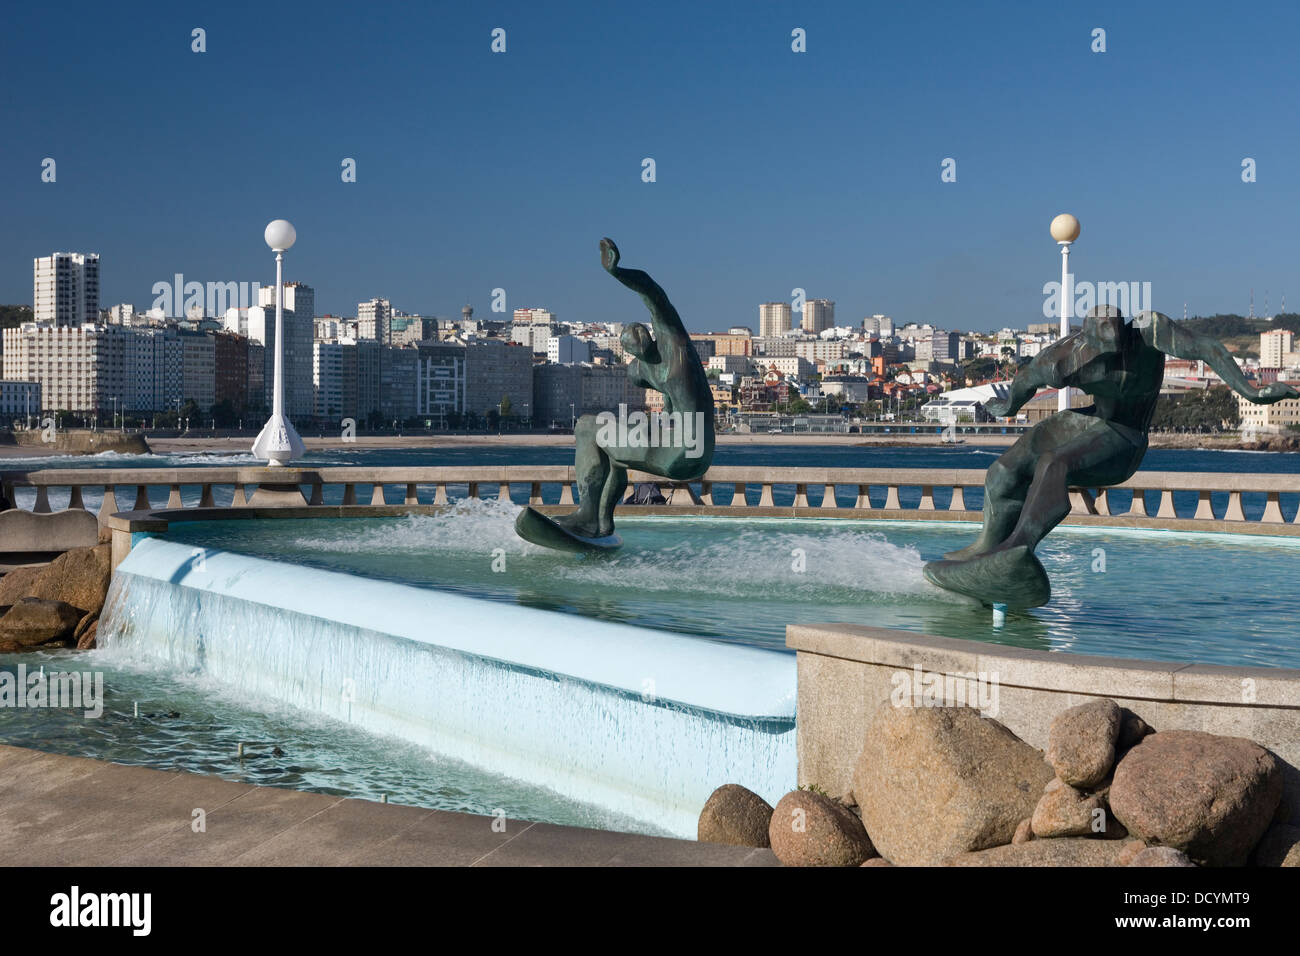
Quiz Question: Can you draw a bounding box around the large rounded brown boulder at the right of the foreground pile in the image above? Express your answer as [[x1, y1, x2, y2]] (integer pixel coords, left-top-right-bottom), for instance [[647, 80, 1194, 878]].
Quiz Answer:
[[1110, 730, 1282, 866]]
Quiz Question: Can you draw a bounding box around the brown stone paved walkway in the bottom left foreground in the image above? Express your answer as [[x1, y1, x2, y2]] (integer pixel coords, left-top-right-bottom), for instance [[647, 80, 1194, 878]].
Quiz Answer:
[[0, 745, 779, 866]]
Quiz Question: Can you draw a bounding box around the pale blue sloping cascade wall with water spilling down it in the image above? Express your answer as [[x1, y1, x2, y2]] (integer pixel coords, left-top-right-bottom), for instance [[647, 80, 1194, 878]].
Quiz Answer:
[[100, 536, 796, 838]]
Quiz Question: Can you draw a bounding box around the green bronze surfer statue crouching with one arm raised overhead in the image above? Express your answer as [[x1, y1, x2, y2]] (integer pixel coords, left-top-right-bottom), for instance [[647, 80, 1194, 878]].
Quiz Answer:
[[515, 239, 714, 551]]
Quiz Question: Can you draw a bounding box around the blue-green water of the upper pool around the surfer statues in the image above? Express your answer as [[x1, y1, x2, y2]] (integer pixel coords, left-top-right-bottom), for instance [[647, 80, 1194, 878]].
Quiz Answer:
[[157, 501, 1300, 667]]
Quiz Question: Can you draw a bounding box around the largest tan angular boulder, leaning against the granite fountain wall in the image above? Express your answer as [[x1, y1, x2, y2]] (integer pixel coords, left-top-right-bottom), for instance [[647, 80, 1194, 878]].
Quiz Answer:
[[853, 702, 1052, 866]]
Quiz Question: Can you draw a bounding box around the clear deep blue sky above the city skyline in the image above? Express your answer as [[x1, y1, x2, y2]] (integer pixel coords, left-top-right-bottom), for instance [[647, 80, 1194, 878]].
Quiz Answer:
[[0, 0, 1300, 330]]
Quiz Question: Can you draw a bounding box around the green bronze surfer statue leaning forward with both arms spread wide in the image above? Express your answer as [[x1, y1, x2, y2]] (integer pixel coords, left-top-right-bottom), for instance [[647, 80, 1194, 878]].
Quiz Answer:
[[926, 306, 1300, 609]]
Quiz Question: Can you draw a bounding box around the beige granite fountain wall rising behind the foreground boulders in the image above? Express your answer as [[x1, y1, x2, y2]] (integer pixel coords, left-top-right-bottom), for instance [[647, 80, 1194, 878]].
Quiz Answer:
[[785, 624, 1300, 821]]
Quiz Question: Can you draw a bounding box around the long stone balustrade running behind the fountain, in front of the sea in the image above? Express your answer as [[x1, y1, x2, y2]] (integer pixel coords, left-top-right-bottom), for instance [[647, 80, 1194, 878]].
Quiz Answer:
[[0, 466, 1300, 533]]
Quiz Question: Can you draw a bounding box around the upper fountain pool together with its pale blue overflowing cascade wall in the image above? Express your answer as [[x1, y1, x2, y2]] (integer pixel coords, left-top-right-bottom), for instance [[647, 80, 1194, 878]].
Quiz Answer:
[[81, 499, 1300, 836]]
